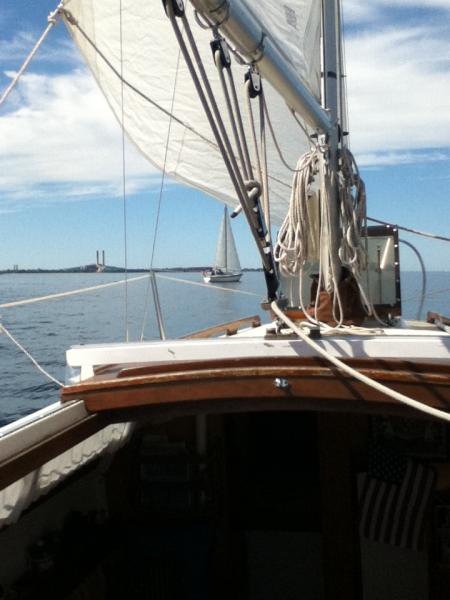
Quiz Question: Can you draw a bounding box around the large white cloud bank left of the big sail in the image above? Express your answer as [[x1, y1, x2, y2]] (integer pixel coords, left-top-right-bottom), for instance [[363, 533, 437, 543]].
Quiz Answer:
[[0, 70, 156, 207]]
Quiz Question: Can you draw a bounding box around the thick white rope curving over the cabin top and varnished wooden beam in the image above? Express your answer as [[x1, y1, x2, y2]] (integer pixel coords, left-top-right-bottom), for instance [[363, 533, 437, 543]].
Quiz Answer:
[[270, 302, 450, 422]]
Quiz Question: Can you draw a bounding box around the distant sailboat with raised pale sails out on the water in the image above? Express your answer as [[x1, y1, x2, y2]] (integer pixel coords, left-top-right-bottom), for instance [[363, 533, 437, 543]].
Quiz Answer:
[[203, 206, 242, 283]]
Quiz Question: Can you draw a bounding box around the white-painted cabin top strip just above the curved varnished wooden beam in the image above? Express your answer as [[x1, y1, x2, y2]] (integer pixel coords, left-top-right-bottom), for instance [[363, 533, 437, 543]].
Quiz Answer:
[[66, 325, 450, 383]]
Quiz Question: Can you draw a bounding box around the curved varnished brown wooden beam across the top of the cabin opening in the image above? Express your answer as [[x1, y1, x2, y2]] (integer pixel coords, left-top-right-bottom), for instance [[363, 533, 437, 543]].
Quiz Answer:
[[62, 357, 450, 414]]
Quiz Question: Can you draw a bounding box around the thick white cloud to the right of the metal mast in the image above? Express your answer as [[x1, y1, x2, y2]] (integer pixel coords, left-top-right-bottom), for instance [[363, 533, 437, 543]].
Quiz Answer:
[[346, 26, 450, 164]]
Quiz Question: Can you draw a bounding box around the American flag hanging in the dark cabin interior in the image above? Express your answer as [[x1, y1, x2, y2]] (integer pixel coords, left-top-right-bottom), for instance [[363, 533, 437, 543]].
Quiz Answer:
[[358, 446, 436, 550]]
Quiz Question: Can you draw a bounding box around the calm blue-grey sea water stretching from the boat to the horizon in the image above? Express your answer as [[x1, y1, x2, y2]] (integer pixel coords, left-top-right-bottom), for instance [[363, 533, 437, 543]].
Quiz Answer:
[[0, 272, 450, 424]]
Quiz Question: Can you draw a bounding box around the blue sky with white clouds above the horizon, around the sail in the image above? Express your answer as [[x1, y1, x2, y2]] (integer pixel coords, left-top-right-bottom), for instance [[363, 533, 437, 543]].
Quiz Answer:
[[0, 0, 450, 270]]
